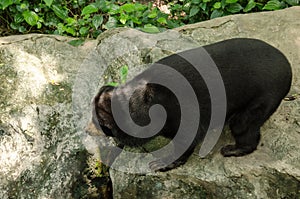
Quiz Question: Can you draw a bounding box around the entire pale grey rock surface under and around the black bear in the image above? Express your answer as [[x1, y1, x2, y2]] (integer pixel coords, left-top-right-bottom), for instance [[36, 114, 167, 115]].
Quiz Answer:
[[0, 7, 300, 199]]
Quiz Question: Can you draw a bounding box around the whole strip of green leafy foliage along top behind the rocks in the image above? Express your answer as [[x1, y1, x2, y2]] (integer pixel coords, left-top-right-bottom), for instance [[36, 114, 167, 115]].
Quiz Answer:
[[0, 0, 300, 38]]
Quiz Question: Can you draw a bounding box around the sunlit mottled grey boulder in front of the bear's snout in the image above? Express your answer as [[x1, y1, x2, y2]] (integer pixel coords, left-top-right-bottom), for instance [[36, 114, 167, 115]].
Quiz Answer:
[[0, 35, 101, 199]]
